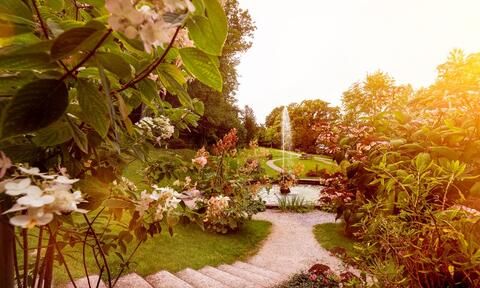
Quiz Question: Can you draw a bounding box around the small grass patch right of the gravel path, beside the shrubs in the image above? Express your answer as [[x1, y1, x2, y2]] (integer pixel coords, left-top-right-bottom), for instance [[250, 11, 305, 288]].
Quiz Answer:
[[313, 223, 356, 257]]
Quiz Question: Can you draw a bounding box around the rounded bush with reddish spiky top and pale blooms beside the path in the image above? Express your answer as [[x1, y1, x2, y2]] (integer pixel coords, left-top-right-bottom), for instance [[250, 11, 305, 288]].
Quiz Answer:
[[146, 129, 268, 233]]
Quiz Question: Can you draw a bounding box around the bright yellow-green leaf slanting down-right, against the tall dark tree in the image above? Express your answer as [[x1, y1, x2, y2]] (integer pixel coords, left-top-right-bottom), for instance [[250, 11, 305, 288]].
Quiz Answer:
[[179, 48, 223, 92]]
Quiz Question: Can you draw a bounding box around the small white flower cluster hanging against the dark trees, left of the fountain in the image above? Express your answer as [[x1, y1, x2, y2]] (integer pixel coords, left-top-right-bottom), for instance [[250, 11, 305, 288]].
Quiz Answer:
[[136, 115, 175, 145]]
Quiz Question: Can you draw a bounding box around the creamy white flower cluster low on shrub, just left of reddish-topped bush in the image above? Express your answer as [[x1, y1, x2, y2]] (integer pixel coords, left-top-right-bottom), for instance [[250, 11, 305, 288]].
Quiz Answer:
[[136, 185, 181, 221]]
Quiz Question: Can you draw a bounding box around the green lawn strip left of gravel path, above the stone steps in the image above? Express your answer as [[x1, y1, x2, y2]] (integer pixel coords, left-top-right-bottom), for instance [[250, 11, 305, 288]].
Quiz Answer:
[[54, 220, 271, 284]]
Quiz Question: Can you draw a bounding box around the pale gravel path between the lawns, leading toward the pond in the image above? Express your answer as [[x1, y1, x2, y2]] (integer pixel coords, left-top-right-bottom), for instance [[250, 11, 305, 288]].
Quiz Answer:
[[248, 210, 355, 275]]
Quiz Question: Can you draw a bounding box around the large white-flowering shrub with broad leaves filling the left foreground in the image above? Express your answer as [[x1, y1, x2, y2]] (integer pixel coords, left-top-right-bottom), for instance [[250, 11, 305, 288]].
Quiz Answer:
[[0, 0, 228, 287]]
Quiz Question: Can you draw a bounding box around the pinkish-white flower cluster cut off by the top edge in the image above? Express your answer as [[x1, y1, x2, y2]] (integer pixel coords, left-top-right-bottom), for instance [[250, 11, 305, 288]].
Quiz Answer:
[[105, 0, 195, 53]]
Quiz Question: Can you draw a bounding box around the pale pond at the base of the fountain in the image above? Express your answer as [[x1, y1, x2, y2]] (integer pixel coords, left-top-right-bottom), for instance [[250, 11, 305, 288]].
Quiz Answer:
[[258, 184, 322, 207]]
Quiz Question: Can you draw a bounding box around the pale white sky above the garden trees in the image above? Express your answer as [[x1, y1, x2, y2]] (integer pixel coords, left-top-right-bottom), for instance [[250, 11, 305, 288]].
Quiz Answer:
[[237, 0, 480, 123]]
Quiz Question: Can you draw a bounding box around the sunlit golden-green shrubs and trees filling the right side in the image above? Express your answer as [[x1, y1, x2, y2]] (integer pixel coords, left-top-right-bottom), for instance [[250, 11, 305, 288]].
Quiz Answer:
[[318, 51, 480, 287]]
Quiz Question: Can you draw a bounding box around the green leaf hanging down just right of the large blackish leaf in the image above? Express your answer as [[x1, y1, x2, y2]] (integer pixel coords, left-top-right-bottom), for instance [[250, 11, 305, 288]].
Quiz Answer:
[[77, 79, 111, 138]]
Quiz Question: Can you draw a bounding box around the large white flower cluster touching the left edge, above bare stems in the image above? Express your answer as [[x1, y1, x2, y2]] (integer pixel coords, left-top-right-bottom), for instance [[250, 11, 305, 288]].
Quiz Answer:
[[0, 167, 87, 228]]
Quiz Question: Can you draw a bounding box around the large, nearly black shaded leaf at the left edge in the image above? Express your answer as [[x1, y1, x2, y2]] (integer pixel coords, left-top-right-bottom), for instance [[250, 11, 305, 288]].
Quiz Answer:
[[0, 79, 68, 138]]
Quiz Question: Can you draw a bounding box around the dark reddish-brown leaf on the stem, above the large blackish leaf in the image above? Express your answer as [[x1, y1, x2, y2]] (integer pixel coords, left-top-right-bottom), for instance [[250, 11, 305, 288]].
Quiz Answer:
[[50, 27, 100, 60]]
